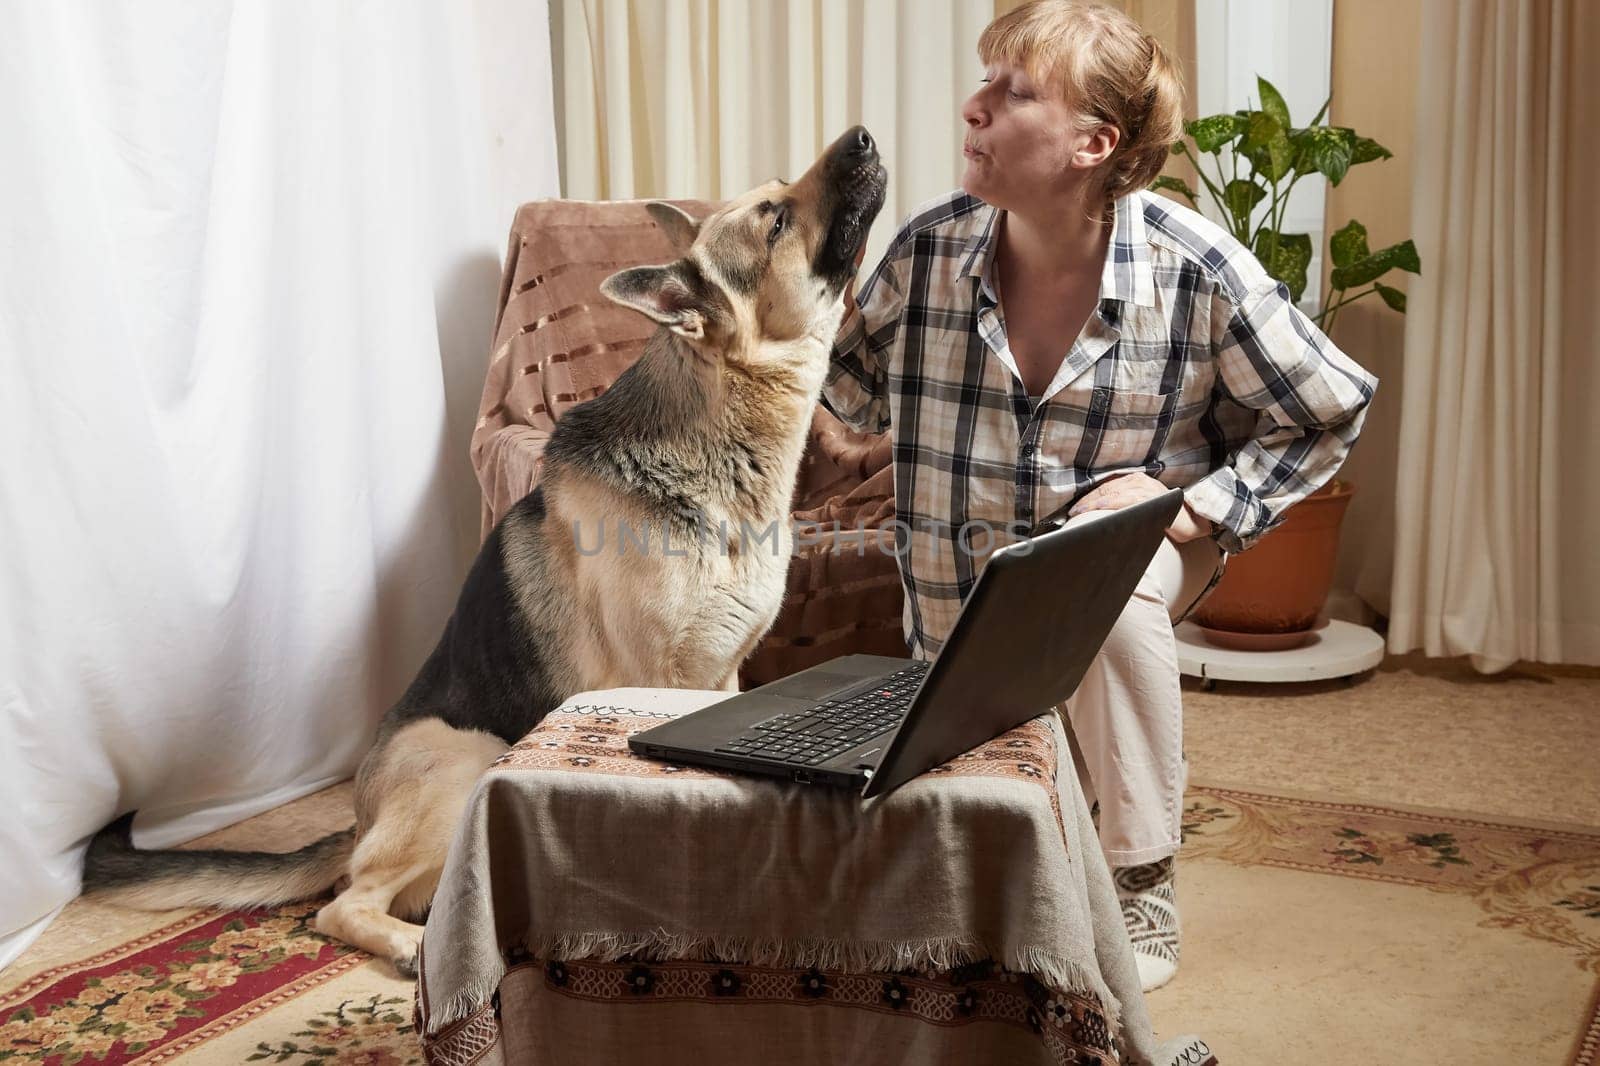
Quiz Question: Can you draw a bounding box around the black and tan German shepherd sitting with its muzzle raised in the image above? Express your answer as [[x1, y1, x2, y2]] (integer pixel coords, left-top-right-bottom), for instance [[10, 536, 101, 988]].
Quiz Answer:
[[85, 126, 886, 975]]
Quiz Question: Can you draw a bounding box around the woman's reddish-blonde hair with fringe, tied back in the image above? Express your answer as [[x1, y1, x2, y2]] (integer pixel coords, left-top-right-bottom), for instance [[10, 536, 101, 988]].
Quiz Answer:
[[978, 0, 1184, 203]]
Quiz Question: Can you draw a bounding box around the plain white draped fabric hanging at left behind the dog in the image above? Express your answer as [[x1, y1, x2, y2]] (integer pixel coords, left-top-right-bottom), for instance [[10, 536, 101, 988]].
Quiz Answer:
[[0, 0, 557, 965]]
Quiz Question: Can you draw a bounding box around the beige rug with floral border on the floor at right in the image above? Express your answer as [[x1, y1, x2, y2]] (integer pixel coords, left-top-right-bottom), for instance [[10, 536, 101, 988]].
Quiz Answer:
[[1152, 787, 1600, 1066]]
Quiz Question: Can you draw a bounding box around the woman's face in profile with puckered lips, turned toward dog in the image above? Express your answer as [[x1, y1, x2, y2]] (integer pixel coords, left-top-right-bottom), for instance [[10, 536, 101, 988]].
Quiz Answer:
[[962, 62, 1117, 211]]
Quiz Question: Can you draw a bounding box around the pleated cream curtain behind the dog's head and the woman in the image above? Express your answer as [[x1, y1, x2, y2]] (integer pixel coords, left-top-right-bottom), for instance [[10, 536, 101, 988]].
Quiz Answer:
[[550, 0, 1194, 259]]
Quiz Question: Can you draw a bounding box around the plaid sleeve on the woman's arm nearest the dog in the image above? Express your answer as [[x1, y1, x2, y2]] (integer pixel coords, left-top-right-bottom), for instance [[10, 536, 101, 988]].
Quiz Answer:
[[822, 245, 904, 432]]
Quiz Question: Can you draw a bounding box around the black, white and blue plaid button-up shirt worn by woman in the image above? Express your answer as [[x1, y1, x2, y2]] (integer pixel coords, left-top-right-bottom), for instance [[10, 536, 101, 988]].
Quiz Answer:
[[822, 192, 1378, 656]]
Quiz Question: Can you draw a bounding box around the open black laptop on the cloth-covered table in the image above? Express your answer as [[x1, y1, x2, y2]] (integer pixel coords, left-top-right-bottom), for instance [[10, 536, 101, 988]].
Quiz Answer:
[[629, 488, 1182, 797]]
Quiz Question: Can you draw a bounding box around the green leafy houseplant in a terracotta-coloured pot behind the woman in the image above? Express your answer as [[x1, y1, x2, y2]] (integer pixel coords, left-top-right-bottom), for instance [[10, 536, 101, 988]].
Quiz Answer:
[[1155, 77, 1422, 648]]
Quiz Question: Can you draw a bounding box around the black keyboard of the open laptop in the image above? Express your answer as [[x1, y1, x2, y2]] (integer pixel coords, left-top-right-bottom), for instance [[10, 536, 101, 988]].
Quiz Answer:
[[717, 661, 928, 767]]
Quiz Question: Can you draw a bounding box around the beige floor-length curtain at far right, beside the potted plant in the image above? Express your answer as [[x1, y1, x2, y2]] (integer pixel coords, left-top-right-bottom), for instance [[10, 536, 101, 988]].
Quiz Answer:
[[1389, 0, 1600, 671]]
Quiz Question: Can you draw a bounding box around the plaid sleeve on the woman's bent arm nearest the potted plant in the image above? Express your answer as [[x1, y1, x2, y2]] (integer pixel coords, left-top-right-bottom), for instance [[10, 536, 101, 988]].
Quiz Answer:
[[1184, 282, 1378, 552]]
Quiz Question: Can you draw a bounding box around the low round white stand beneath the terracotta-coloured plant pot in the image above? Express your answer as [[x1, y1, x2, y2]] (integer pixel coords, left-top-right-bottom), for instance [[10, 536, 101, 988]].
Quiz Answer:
[[1173, 618, 1384, 691]]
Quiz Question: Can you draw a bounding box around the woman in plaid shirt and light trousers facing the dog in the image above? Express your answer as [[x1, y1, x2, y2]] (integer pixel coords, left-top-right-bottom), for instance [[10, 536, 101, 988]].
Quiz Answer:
[[824, 0, 1376, 989]]
